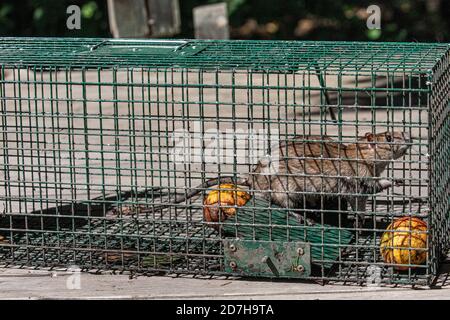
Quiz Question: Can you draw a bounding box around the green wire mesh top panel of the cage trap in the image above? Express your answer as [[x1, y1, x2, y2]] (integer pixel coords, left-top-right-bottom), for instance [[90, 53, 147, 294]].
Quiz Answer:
[[0, 38, 449, 73]]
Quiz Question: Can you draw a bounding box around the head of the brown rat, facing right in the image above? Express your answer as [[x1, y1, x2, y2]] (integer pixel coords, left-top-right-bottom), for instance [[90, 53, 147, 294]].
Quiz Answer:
[[362, 131, 412, 160]]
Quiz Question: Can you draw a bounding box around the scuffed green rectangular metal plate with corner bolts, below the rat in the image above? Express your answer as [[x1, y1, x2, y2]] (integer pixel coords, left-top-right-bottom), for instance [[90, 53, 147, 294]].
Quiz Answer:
[[223, 239, 311, 278]]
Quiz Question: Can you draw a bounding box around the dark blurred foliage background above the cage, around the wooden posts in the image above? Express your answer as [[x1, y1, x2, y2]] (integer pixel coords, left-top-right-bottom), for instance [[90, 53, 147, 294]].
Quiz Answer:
[[0, 0, 450, 42]]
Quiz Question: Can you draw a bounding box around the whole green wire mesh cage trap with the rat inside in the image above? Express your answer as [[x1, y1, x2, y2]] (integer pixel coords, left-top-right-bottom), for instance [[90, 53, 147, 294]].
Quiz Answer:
[[0, 38, 450, 285]]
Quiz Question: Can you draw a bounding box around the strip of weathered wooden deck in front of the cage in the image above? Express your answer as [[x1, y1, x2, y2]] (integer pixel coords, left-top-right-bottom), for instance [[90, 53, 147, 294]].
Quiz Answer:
[[0, 255, 450, 300]]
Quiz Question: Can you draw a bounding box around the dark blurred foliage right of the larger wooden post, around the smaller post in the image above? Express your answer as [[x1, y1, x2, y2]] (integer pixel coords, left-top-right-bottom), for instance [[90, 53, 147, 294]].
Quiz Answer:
[[180, 0, 450, 42]]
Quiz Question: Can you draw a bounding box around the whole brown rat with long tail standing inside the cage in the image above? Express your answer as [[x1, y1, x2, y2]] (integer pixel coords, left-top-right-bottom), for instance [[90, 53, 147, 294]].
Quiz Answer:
[[135, 131, 411, 228]]
